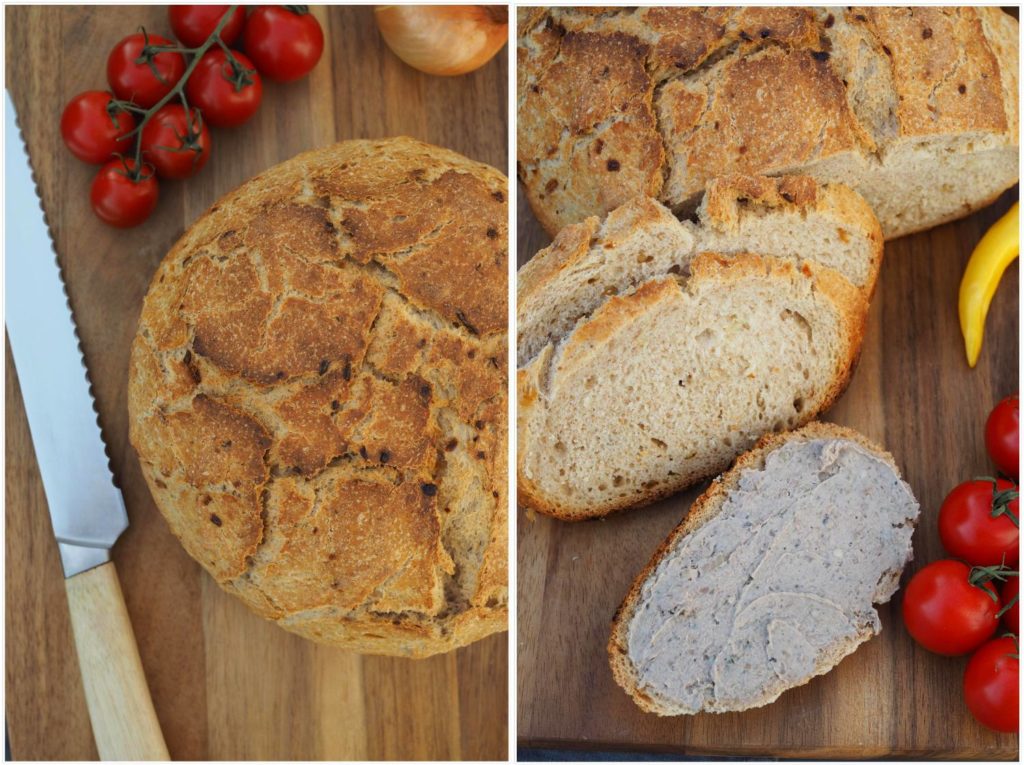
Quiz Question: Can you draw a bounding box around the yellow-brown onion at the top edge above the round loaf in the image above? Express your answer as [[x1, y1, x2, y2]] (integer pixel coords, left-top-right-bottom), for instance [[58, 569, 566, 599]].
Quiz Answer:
[[374, 5, 509, 77]]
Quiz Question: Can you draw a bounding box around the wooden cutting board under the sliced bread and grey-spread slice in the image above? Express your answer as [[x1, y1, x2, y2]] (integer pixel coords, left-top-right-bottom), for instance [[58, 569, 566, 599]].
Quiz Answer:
[[517, 187, 1019, 760]]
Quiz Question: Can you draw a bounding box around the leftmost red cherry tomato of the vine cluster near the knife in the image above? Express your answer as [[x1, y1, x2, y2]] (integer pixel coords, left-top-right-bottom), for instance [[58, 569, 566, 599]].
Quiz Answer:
[[60, 90, 135, 165]]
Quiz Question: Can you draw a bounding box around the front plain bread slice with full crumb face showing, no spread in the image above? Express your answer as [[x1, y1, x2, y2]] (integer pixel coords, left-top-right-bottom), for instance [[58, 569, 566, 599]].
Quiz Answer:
[[518, 253, 867, 520]]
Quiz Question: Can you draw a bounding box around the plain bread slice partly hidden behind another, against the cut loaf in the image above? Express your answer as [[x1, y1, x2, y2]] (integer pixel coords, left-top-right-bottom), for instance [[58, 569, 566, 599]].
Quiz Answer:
[[517, 175, 883, 367]]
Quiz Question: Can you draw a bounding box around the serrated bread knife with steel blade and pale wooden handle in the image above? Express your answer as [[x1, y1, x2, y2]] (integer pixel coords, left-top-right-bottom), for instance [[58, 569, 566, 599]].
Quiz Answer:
[[4, 91, 170, 760]]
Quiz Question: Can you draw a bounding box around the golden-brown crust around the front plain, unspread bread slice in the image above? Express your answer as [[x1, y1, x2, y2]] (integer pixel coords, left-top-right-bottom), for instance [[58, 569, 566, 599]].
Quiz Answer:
[[516, 253, 867, 520]]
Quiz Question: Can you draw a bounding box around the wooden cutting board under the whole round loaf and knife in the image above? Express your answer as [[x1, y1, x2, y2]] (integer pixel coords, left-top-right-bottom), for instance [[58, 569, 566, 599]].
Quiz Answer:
[[5, 6, 507, 760]]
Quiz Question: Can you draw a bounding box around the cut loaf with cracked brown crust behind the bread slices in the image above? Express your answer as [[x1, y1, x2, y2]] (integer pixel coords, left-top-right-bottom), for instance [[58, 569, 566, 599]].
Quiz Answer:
[[517, 7, 1019, 239]]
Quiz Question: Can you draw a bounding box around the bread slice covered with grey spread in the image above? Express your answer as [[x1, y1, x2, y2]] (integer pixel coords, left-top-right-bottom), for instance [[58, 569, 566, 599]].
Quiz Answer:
[[608, 423, 919, 715]]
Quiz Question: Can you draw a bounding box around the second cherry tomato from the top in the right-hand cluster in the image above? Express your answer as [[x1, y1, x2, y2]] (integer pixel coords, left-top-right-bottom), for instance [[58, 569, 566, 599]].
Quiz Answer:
[[939, 479, 1020, 566]]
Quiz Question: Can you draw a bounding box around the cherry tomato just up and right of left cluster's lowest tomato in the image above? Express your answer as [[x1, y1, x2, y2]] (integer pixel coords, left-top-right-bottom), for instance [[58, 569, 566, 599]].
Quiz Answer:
[[141, 103, 210, 179]]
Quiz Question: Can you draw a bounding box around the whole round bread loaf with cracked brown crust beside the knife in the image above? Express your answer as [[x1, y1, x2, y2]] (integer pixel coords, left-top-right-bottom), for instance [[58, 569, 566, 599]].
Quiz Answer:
[[128, 138, 508, 656]]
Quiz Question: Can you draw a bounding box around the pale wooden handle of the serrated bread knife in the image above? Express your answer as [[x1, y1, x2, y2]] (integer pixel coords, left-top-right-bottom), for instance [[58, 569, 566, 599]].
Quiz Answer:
[[65, 562, 170, 760]]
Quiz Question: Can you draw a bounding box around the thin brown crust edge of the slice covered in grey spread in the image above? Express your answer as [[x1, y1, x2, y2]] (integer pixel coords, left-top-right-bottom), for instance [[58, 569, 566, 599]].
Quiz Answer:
[[607, 422, 900, 715]]
